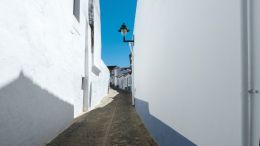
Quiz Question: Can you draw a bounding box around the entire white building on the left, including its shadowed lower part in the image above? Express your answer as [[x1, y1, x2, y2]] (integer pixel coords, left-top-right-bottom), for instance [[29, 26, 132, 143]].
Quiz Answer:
[[0, 0, 109, 146]]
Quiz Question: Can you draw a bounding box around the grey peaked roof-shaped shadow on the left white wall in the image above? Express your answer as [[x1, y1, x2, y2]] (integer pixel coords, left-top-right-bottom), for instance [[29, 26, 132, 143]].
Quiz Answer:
[[0, 72, 74, 146]]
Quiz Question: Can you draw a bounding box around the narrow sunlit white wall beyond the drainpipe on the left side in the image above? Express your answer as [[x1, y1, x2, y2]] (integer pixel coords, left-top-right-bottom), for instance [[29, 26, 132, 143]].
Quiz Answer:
[[87, 0, 110, 110]]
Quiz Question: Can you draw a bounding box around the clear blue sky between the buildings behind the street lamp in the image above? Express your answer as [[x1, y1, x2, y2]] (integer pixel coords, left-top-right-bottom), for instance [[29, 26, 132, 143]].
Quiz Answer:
[[100, 0, 137, 67]]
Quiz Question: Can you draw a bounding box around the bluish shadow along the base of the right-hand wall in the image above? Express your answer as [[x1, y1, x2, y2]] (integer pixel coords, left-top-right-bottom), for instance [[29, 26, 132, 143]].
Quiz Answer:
[[135, 98, 196, 146]]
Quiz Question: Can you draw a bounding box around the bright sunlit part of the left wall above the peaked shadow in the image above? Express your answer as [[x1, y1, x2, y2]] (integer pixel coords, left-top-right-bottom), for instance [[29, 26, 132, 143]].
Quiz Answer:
[[0, 0, 84, 114]]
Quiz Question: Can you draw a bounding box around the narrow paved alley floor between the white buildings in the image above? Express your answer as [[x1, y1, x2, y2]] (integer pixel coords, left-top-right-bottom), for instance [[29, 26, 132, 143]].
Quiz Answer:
[[47, 89, 156, 146]]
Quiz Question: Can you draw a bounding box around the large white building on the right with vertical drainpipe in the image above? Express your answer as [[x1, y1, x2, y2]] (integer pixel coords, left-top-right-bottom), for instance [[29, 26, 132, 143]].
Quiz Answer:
[[133, 0, 260, 146]]
